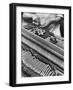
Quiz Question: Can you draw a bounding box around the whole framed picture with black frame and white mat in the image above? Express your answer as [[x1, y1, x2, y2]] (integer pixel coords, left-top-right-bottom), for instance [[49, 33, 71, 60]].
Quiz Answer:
[[10, 4, 71, 86]]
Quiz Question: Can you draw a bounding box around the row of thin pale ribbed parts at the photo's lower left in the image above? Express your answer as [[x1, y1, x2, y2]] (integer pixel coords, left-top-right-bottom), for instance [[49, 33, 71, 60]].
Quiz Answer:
[[22, 50, 56, 76]]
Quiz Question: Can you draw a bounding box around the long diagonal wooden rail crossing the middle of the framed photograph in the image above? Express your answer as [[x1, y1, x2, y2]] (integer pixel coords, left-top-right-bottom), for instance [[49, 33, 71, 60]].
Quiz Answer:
[[21, 30, 64, 73]]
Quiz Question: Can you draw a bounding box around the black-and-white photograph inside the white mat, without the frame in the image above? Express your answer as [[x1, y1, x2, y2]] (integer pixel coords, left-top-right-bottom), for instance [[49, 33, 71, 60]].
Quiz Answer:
[[21, 12, 64, 77]]
